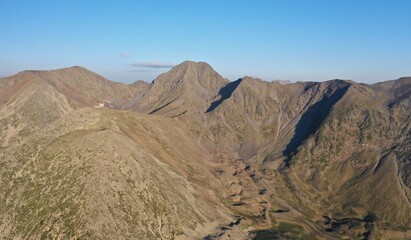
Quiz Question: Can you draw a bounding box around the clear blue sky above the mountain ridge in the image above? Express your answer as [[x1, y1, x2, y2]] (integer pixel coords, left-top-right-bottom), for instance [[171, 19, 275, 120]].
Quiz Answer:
[[0, 0, 411, 83]]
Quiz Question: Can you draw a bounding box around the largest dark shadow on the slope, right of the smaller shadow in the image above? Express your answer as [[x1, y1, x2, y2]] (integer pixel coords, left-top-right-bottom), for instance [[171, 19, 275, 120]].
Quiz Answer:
[[283, 82, 350, 166]]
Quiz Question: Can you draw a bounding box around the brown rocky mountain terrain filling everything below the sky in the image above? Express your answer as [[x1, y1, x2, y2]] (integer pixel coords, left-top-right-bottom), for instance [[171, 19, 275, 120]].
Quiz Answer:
[[0, 61, 411, 239]]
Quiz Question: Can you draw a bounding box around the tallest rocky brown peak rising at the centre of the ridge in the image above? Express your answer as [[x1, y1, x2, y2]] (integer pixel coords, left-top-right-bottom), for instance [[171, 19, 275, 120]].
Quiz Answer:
[[128, 61, 228, 116]]
